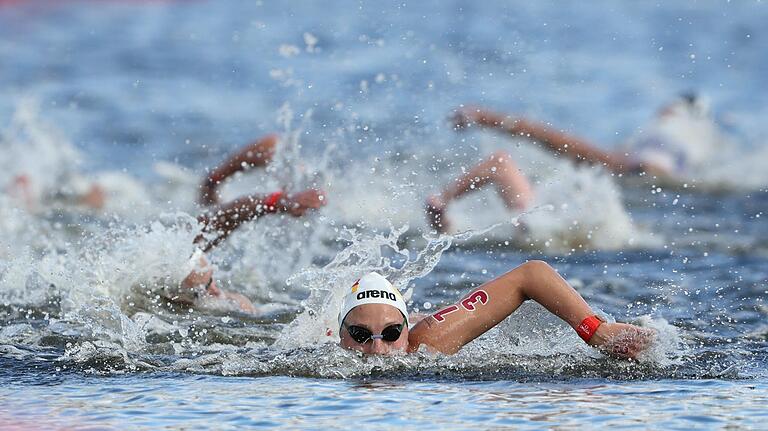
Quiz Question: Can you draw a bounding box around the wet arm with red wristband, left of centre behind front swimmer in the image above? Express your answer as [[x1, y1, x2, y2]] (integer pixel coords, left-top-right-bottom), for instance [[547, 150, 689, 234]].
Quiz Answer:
[[195, 189, 326, 251]]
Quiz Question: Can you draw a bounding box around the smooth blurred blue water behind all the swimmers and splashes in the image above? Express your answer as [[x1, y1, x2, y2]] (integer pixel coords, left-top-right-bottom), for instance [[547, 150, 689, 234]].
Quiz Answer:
[[0, 1, 768, 172]]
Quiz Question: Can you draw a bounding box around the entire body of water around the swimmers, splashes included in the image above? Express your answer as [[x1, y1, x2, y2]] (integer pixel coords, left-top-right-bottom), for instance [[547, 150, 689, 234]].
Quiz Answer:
[[0, 1, 768, 429]]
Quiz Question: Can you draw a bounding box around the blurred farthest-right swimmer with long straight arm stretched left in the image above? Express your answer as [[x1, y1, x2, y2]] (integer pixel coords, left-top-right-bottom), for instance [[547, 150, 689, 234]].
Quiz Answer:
[[453, 94, 726, 181]]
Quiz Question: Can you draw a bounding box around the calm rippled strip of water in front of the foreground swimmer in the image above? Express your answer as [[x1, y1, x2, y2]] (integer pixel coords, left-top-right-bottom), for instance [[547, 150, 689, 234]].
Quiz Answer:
[[0, 375, 768, 429]]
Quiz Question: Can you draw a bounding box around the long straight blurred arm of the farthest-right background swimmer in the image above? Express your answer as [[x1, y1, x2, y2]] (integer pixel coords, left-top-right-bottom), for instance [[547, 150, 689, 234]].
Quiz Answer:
[[453, 107, 638, 174]]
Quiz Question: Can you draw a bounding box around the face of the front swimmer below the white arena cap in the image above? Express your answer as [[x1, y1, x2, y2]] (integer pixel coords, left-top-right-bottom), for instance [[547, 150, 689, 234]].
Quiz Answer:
[[340, 304, 408, 355]]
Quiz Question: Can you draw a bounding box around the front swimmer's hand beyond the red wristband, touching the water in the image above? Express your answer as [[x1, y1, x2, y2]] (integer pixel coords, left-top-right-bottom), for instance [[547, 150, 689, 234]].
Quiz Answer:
[[589, 323, 656, 359]]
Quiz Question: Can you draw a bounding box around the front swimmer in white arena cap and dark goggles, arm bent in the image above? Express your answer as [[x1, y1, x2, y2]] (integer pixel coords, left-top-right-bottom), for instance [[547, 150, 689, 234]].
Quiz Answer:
[[339, 261, 655, 359]]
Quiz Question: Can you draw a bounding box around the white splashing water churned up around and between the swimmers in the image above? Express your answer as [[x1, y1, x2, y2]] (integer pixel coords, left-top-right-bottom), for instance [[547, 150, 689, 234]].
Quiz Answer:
[[2, 98, 704, 377]]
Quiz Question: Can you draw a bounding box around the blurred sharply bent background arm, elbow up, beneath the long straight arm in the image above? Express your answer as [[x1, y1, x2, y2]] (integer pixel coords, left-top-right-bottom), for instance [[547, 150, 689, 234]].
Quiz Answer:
[[426, 151, 533, 232]]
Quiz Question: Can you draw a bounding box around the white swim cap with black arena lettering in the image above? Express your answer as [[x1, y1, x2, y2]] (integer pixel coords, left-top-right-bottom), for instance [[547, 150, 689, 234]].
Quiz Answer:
[[339, 272, 408, 327]]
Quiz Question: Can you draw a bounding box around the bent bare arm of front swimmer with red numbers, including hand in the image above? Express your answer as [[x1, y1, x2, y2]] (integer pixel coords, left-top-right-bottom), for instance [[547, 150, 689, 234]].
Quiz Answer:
[[408, 261, 653, 358]]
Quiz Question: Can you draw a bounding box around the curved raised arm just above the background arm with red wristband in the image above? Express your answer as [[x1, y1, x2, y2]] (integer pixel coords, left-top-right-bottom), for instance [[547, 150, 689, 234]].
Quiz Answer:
[[200, 135, 278, 205]]
